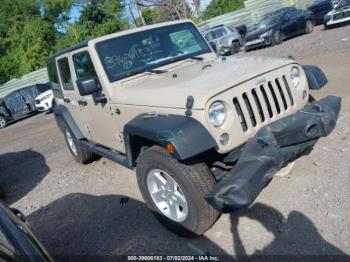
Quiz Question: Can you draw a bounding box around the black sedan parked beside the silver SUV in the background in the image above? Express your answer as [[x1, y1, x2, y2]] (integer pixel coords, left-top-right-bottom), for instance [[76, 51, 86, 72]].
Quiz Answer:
[[245, 7, 314, 50]]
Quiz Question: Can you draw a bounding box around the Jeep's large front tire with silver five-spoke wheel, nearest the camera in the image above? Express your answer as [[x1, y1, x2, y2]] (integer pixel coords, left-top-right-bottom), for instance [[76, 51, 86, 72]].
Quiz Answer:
[[136, 146, 219, 236]]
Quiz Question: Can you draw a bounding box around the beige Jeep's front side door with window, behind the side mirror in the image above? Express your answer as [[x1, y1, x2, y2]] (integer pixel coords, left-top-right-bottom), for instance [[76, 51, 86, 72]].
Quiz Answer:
[[72, 49, 124, 151]]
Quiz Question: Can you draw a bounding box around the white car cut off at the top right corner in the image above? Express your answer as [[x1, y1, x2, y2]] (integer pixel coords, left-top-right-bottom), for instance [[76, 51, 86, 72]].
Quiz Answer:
[[324, 0, 350, 28]]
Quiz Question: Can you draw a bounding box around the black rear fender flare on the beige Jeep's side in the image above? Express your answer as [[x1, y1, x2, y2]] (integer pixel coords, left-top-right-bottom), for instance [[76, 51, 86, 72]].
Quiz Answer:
[[53, 105, 84, 140]]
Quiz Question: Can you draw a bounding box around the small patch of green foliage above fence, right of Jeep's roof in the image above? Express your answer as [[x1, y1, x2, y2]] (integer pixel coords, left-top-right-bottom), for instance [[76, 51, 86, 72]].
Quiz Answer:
[[203, 0, 244, 19]]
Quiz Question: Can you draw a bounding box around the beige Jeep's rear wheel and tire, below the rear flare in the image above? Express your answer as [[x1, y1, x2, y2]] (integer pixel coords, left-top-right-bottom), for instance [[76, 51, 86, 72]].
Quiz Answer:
[[64, 128, 96, 164]]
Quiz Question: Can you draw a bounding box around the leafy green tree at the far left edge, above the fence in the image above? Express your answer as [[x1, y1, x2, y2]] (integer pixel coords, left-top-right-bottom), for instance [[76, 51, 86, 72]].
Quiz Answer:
[[0, 0, 56, 84]]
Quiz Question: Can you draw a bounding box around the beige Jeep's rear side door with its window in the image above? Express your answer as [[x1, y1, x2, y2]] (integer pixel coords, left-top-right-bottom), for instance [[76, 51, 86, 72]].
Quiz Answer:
[[56, 55, 92, 139]]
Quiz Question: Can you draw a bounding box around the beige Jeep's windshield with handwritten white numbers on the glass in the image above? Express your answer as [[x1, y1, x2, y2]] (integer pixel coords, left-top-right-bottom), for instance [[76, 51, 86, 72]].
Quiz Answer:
[[96, 23, 211, 82]]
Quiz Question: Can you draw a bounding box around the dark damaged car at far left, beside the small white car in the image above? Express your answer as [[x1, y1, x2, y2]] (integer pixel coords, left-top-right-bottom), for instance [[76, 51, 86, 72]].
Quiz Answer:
[[0, 84, 48, 129]]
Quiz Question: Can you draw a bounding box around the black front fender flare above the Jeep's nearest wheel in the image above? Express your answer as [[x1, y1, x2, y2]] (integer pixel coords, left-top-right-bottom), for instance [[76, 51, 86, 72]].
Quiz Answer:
[[124, 114, 217, 162]]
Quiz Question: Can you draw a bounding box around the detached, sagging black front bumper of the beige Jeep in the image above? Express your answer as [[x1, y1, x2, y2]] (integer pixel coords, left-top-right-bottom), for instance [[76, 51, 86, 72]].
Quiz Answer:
[[205, 96, 341, 213]]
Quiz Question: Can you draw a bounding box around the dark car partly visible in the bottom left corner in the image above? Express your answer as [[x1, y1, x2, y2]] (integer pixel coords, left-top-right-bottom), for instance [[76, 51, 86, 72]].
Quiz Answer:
[[0, 202, 53, 262]]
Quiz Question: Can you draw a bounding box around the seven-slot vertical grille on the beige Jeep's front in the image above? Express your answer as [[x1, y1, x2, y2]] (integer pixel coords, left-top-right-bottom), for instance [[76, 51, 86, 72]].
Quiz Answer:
[[233, 76, 294, 132]]
